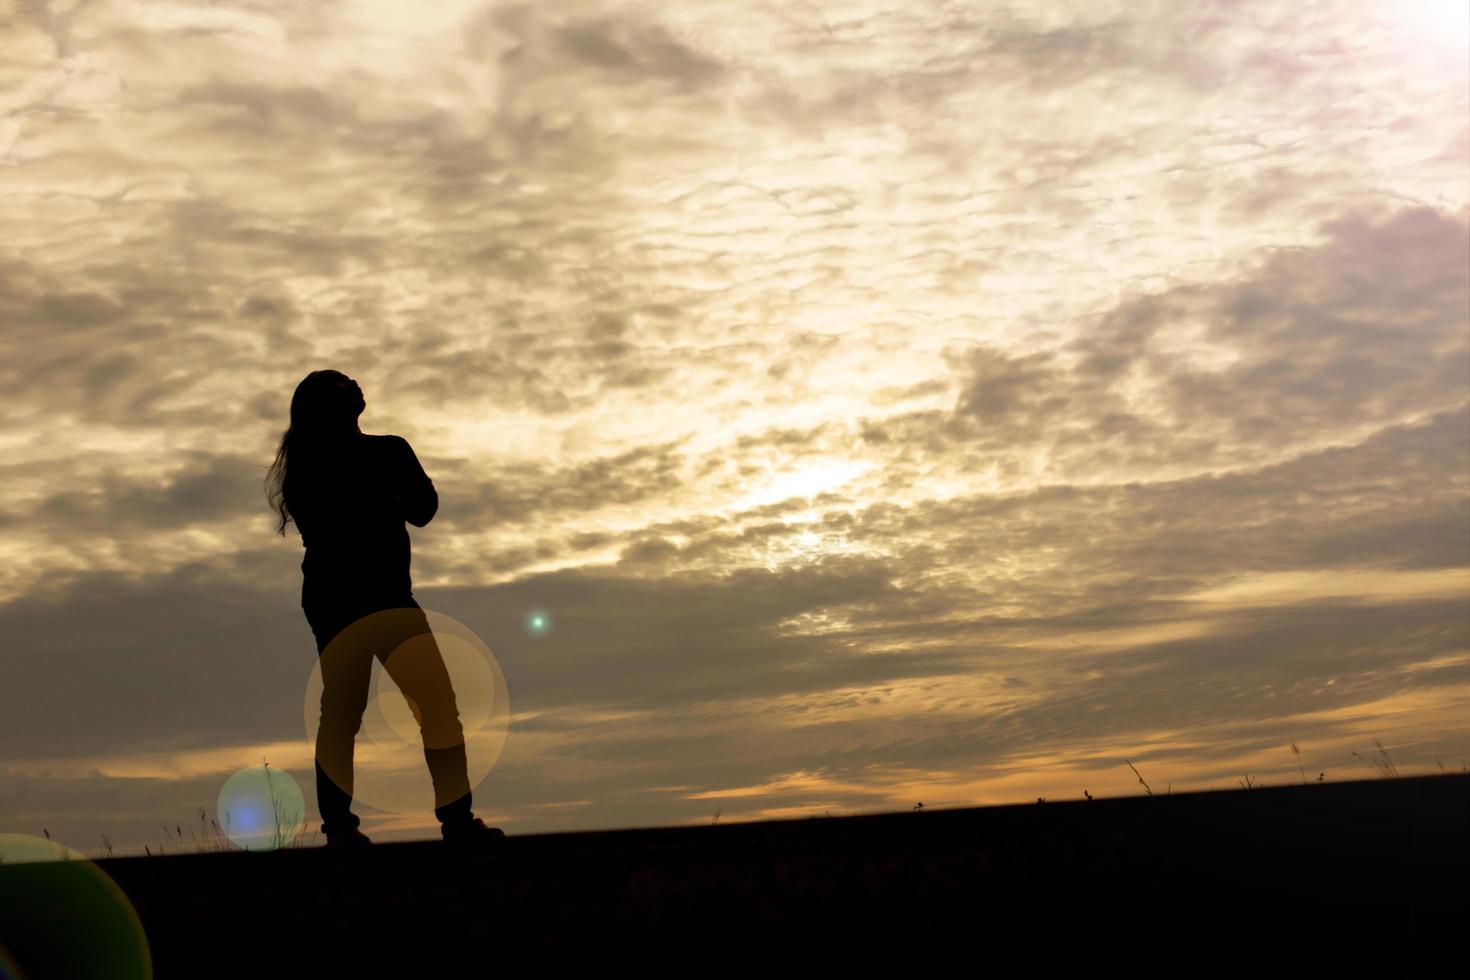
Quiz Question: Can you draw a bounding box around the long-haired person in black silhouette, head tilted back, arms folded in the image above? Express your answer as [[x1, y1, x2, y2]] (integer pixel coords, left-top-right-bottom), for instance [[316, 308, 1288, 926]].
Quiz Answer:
[[266, 370, 504, 845]]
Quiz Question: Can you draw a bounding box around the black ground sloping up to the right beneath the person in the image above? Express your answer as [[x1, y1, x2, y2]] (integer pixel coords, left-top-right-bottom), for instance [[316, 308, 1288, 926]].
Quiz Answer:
[[0, 773, 1470, 980]]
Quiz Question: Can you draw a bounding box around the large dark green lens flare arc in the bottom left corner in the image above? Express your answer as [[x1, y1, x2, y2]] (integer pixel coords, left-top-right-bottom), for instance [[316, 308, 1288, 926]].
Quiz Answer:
[[0, 833, 153, 980]]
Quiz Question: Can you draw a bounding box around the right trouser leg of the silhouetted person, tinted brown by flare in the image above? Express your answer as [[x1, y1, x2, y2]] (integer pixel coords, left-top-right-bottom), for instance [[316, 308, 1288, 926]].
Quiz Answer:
[[382, 599, 473, 823]]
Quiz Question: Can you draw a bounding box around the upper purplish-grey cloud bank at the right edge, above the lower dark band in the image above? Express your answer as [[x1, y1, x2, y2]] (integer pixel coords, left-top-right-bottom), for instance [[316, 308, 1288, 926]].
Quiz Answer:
[[929, 209, 1470, 479]]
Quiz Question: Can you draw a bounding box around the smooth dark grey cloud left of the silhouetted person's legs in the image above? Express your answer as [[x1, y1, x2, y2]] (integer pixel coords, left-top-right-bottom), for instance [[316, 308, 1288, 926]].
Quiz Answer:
[[0, 561, 315, 760]]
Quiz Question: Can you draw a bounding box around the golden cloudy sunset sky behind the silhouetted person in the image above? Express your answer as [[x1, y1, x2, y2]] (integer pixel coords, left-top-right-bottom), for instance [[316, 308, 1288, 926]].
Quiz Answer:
[[0, 0, 1470, 854]]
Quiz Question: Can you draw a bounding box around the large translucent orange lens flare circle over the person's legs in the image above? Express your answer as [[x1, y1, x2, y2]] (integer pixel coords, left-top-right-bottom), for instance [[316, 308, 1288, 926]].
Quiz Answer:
[[304, 607, 510, 813]]
